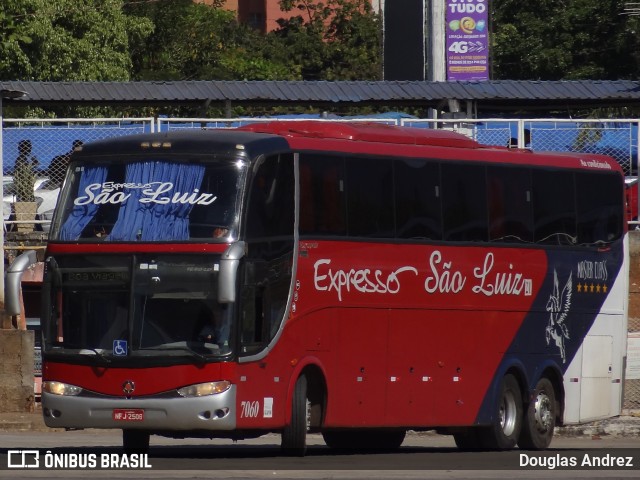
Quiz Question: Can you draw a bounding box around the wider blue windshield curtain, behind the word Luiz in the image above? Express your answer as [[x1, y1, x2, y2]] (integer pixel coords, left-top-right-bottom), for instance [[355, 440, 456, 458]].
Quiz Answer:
[[106, 162, 204, 241]]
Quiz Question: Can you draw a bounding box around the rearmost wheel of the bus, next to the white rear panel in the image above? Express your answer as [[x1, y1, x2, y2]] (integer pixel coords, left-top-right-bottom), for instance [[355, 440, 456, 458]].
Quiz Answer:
[[518, 378, 556, 450]]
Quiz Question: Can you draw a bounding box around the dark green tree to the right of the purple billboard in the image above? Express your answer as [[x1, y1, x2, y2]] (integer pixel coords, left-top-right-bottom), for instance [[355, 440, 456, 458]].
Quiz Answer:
[[491, 0, 639, 80]]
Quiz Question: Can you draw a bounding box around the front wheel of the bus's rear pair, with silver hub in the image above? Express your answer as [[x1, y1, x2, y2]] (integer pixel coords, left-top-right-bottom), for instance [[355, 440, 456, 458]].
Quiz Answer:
[[479, 375, 523, 450]]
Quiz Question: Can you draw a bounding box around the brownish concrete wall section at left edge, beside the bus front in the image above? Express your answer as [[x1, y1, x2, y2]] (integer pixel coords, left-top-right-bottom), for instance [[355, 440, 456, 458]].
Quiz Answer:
[[0, 330, 35, 412]]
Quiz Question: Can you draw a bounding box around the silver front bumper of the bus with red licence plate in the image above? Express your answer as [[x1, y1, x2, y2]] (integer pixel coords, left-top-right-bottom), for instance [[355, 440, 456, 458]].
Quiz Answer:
[[42, 385, 236, 431]]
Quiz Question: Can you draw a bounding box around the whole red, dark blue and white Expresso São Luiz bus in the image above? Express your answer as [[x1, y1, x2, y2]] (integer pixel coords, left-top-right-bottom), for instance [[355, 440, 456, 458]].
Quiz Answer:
[[42, 121, 629, 455]]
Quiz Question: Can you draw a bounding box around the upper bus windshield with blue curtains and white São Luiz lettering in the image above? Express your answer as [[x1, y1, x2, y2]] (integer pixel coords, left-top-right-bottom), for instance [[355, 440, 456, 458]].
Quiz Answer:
[[50, 157, 246, 242]]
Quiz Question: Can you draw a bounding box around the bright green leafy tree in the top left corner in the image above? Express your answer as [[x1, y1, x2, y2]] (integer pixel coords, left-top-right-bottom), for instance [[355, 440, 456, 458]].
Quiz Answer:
[[0, 0, 152, 81]]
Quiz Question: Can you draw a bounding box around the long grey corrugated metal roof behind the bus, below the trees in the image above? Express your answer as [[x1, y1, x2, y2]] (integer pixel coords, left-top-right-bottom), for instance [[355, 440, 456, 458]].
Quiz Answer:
[[0, 80, 640, 112]]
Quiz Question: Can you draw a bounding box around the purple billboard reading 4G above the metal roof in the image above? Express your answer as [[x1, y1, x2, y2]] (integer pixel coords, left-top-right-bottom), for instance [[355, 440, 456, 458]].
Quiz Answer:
[[445, 0, 489, 81]]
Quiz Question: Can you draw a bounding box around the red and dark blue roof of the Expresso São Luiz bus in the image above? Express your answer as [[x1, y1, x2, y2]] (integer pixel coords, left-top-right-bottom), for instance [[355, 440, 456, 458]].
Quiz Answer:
[[75, 120, 623, 175]]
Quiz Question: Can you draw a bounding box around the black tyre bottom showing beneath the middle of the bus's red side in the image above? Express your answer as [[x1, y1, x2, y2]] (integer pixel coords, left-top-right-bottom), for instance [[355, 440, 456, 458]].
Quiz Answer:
[[322, 429, 407, 451]]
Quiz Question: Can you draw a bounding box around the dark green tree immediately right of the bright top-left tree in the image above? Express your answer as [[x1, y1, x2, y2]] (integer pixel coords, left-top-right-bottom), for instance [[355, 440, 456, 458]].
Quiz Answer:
[[126, 0, 288, 80]]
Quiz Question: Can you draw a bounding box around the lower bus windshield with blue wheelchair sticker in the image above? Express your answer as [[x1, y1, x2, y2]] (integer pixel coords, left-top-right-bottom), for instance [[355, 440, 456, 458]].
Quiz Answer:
[[43, 255, 232, 361]]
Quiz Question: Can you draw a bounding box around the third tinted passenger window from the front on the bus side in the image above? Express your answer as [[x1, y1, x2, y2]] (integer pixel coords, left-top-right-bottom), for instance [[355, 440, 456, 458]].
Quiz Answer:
[[394, 159, 442, 240]]
